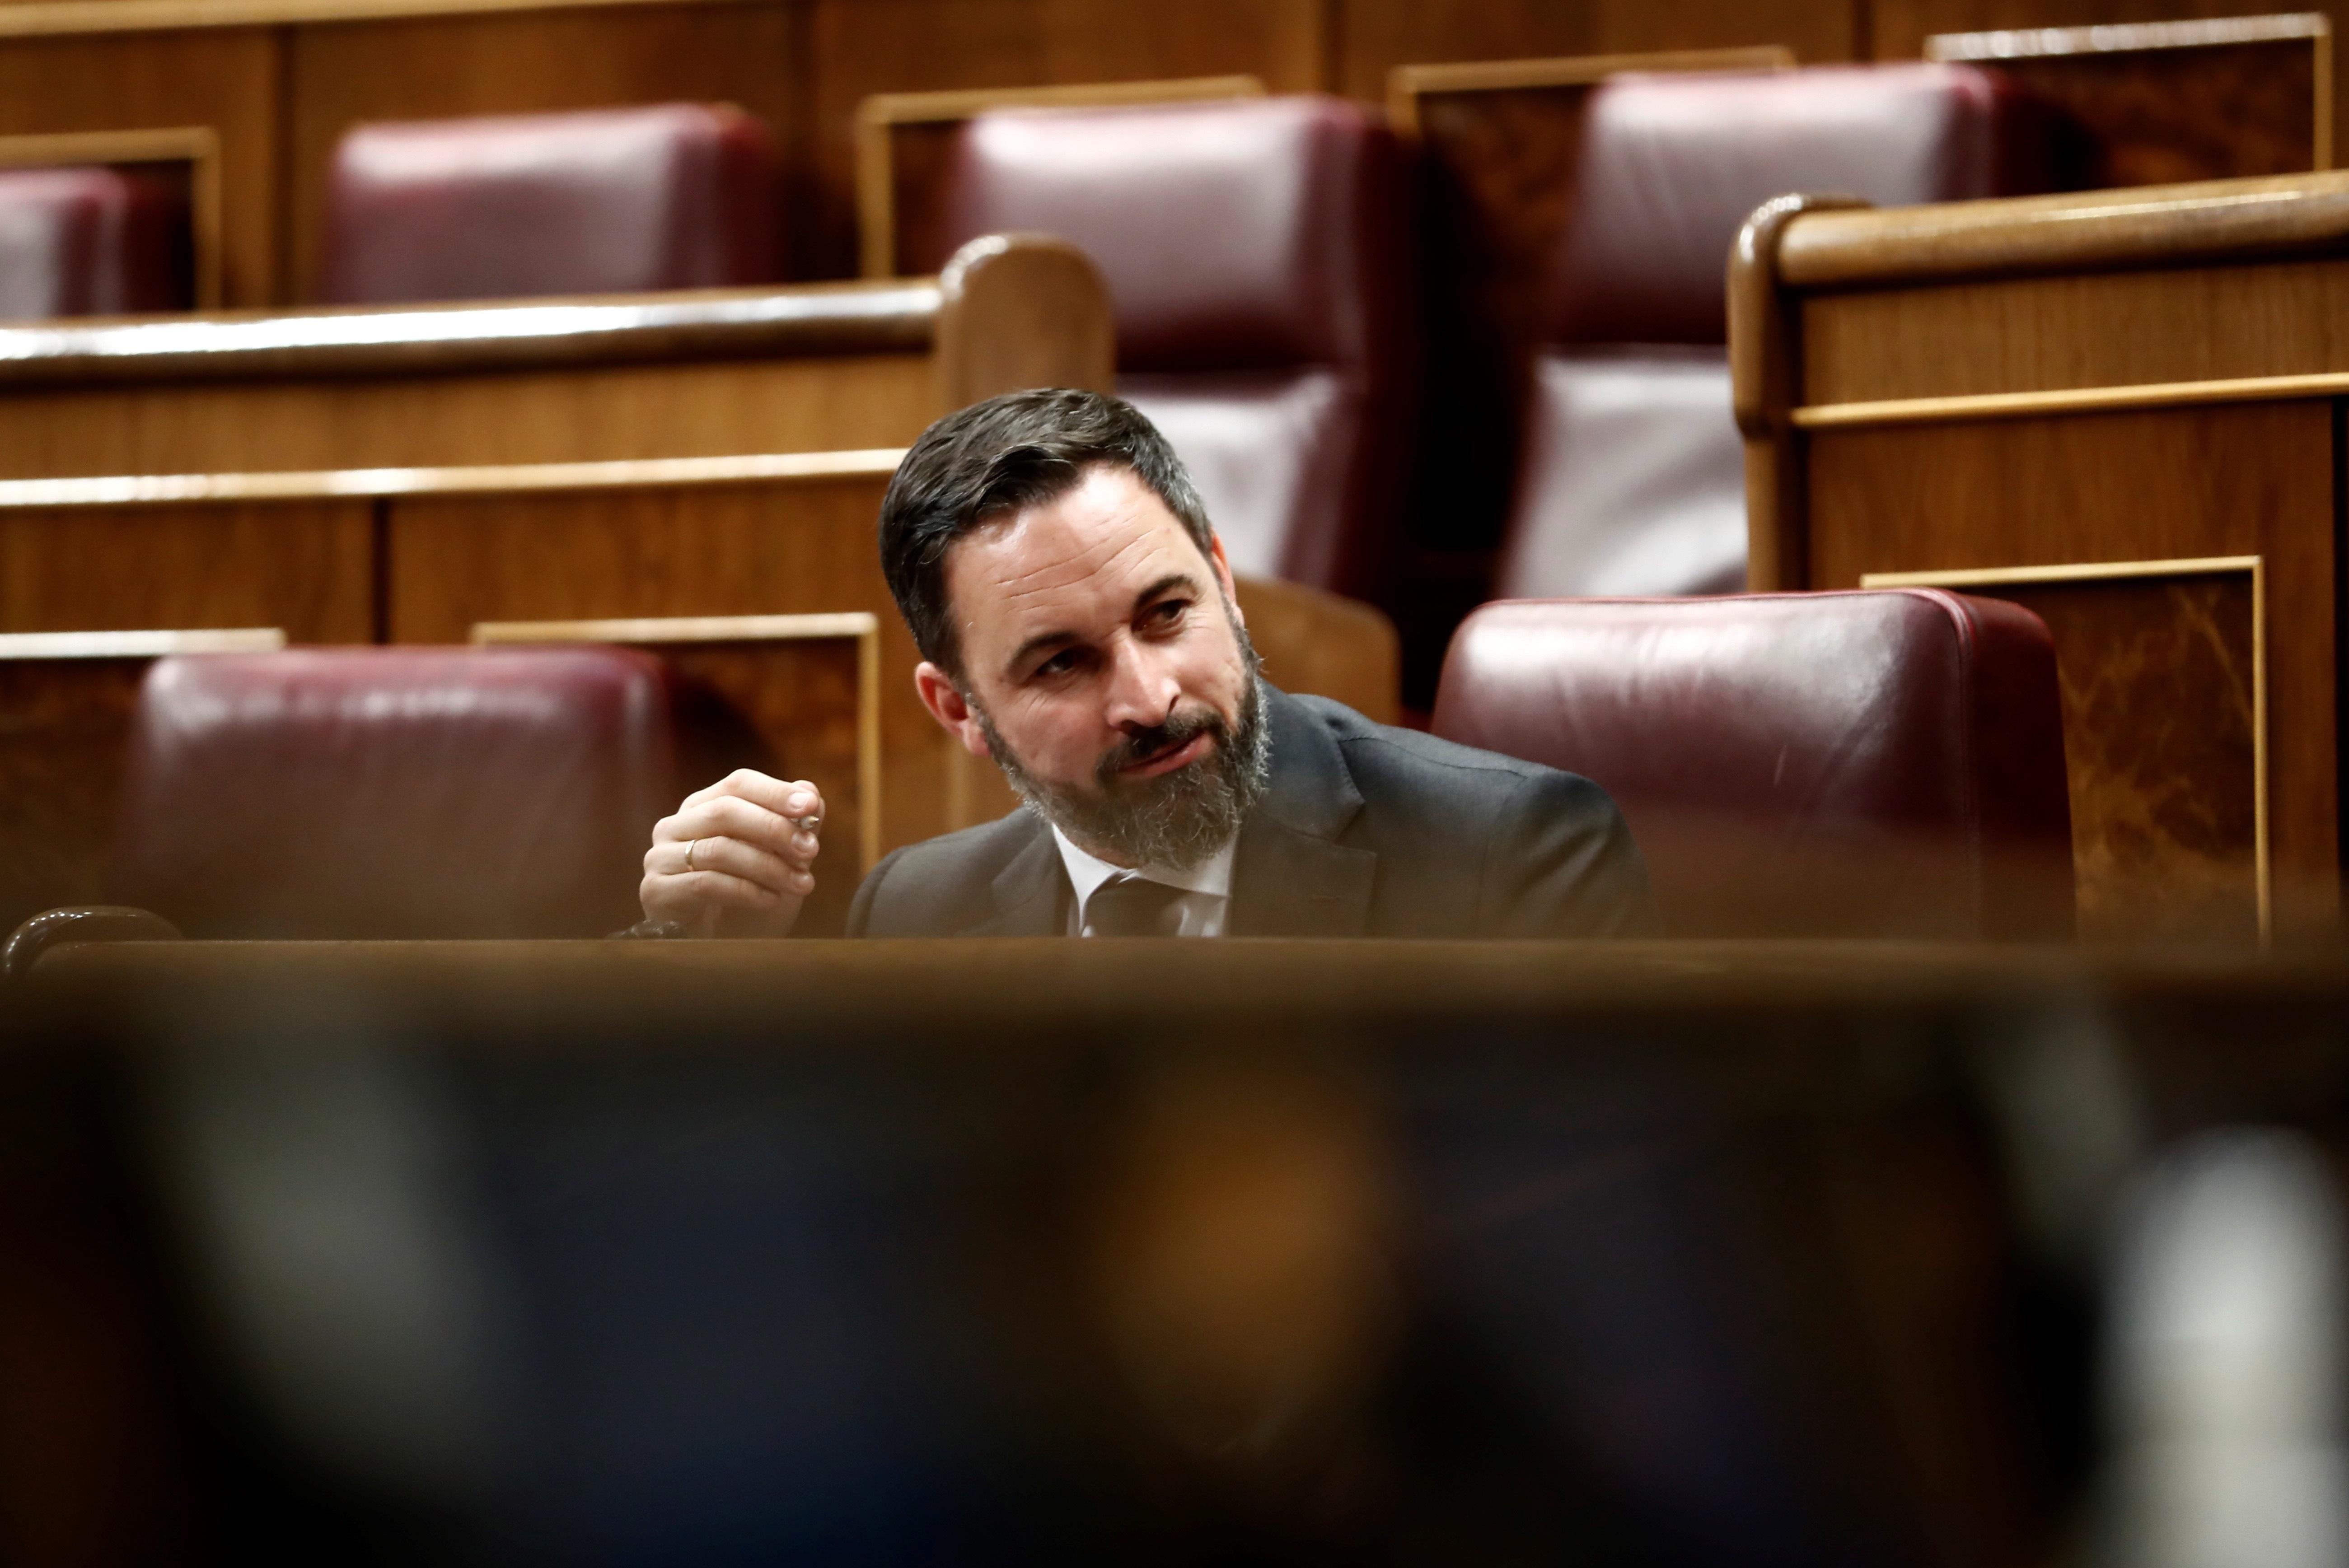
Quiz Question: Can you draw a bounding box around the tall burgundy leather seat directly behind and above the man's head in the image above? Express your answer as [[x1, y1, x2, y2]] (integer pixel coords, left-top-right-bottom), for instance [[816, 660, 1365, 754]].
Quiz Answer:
[[942, 96, 1412, 598]]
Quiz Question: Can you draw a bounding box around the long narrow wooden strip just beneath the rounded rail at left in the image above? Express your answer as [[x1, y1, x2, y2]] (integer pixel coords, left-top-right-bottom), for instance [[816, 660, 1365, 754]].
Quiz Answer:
[[0, 355, 932, 479]]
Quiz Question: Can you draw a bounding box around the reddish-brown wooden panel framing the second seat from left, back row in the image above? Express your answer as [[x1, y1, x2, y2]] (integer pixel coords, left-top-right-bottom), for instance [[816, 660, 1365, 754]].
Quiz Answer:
[[286, 0, 794, 300]]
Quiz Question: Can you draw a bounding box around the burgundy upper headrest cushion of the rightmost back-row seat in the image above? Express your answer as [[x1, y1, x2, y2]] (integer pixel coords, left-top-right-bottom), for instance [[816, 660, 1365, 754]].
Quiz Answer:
[[1550, 63, 2051, 343]]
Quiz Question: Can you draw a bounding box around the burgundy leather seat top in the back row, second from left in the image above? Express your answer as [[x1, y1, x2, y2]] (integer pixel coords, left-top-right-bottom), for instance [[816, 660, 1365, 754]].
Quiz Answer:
[[319, 103, 782, 303]]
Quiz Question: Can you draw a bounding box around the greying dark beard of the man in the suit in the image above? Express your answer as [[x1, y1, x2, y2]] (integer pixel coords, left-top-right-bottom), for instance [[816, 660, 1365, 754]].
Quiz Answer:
[[965, 622, 1273, 871]]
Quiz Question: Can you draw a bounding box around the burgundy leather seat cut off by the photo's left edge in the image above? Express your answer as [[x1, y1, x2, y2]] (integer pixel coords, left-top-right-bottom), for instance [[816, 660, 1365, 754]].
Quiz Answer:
[[0, 169, 195, 322]]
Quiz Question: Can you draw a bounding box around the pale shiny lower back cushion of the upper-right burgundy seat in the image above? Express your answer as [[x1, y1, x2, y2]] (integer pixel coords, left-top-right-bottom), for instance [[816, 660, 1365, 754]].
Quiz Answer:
[[1494, 345, 1745, 598]]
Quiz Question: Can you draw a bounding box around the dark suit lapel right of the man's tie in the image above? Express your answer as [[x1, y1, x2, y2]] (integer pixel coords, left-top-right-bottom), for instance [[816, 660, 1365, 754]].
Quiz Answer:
[[1231, 686, 1379, 937]]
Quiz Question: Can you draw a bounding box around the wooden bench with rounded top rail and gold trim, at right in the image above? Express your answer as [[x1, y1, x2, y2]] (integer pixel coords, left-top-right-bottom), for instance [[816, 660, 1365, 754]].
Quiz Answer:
[[1729, 174, 2349, 939]]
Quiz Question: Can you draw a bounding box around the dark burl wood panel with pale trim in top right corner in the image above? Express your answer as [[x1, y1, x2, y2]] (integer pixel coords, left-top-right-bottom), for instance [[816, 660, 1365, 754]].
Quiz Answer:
[[1926, 16, 2333, 190]]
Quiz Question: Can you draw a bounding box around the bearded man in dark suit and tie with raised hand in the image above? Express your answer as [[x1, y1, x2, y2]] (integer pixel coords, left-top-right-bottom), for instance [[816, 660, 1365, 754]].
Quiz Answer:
[[639, 392, 1654, 937]]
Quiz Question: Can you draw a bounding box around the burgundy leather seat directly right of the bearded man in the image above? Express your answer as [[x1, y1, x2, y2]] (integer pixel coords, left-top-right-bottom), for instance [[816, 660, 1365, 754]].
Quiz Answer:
[[1435, 589, 2072, 939]]
